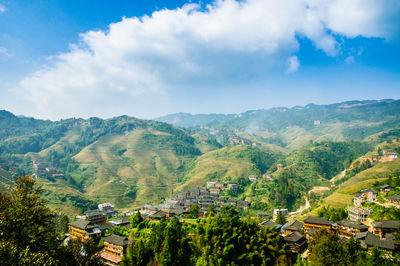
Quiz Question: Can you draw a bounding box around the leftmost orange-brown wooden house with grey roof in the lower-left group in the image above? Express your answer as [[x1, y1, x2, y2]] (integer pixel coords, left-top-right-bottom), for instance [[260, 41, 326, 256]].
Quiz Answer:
[[69, 219, 101, 241]]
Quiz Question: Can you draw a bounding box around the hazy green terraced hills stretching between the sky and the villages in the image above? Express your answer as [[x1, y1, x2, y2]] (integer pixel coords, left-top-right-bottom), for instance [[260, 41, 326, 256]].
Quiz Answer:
[[0, 100, 400, 213]]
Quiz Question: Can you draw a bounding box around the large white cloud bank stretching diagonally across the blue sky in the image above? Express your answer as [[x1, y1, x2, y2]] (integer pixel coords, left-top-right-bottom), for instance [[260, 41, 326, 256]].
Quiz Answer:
[[14, 0, 399, 118]]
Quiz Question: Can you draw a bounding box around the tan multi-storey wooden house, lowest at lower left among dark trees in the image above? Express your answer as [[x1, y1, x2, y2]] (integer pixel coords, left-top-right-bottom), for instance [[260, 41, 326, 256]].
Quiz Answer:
[[100, 234, 128, 265]]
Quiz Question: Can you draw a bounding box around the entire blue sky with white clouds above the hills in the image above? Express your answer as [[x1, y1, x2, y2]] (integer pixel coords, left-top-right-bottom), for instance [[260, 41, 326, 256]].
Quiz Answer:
[[0, 0, 400, 120]]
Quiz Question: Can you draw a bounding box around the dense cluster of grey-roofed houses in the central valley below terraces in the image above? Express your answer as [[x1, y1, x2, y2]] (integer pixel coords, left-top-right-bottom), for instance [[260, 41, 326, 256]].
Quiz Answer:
[[140, 184, 249, 220]]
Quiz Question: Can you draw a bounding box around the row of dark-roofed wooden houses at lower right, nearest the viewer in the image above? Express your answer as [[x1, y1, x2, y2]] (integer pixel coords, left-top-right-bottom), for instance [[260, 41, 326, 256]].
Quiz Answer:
[[260, 217, 400, 256]]
